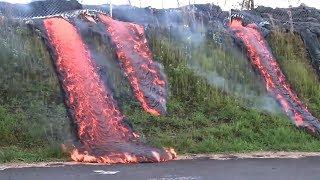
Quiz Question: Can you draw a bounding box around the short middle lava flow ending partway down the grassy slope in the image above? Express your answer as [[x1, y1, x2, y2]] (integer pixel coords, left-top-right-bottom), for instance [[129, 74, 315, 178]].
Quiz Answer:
[[98, 14, 167, 116]]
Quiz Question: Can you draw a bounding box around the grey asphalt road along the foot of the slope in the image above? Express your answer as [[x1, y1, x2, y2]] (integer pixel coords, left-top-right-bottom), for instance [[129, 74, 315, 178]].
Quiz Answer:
[[0, 157, 320, 180]]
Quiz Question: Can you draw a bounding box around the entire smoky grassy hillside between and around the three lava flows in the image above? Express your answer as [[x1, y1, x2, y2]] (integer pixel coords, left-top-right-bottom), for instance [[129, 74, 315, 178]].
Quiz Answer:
[[0, 0, 320, 162]]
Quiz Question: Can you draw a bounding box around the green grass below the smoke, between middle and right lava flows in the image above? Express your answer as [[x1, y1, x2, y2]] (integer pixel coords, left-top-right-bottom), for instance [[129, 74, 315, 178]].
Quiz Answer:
[[125, 28, 320, 153]]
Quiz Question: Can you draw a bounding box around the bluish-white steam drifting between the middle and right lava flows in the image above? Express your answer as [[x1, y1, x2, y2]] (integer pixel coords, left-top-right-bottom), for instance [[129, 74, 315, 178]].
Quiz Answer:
[[101, 5, 281, 113]]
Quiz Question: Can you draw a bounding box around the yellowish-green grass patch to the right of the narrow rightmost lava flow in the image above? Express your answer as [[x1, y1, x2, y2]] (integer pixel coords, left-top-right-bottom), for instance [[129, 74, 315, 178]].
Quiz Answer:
[[269, 31, 320, 118]]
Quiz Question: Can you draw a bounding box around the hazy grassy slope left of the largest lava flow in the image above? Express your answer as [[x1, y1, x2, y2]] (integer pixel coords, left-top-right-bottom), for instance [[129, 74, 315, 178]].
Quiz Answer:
[[0, 22, 69, 162]]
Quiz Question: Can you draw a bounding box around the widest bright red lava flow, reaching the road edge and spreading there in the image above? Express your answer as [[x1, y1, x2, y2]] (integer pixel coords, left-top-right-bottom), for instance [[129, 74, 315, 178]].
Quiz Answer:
[[43, 17, 175, 163]]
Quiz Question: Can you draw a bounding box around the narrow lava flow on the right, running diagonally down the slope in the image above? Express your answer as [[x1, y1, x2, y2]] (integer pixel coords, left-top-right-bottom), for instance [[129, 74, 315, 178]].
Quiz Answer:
[[230, 18, 320, 134]]
